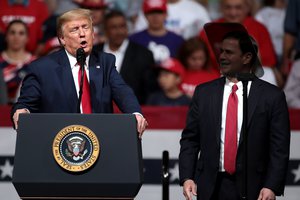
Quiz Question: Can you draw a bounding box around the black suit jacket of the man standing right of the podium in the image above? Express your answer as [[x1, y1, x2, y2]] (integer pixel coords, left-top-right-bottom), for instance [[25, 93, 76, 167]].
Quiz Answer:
[[179, 77, 290, 200]]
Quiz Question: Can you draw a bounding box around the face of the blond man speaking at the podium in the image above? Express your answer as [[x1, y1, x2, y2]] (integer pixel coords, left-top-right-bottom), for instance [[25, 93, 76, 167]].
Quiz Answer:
[[60, 18, 93, 56]]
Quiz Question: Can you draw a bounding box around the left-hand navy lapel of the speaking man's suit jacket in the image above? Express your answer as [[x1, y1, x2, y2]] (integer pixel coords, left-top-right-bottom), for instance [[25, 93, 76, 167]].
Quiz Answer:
[[56, 49, 78, 112]]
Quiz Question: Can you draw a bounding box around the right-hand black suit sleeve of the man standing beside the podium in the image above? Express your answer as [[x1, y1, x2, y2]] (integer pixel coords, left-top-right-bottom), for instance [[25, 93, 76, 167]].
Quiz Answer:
[[264, 91, 290, 195]]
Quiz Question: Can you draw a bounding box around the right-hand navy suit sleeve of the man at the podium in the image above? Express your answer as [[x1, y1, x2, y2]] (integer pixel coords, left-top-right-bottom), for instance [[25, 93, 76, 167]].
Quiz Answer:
[[108, 56, 142, 113]]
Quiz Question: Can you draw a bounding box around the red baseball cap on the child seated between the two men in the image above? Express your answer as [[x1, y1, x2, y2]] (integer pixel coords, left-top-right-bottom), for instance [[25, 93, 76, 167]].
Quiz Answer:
[[158, 58, 185, 79]]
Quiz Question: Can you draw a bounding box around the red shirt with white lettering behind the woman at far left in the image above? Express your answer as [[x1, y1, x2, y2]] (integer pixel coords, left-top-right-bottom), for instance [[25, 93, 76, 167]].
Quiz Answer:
[[0, 0, 49, 52]]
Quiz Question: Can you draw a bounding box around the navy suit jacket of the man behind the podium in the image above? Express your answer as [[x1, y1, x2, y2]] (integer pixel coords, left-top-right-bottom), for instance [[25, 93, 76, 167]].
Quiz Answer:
[[12, 49, 141, 114]]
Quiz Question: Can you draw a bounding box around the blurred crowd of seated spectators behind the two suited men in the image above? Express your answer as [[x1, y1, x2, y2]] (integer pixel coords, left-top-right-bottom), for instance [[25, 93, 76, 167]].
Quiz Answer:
[[0, 0, 300, 108]]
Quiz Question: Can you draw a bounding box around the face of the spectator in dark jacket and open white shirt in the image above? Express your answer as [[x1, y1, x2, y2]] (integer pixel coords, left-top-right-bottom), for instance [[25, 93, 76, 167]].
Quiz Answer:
[[105, 16, 128, 46]]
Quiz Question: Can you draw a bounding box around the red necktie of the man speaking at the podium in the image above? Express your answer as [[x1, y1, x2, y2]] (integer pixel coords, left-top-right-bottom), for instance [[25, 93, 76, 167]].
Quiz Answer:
[[78, 67, 92, 114]]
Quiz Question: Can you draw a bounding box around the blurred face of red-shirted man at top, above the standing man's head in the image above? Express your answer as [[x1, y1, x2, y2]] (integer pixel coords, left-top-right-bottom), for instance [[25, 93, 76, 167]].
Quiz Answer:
[[221, 0, 249, 23]]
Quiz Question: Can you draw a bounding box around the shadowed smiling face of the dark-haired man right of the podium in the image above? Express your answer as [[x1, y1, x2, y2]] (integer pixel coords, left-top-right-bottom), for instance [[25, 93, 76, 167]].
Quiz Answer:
[[219, 38, 251, 77]]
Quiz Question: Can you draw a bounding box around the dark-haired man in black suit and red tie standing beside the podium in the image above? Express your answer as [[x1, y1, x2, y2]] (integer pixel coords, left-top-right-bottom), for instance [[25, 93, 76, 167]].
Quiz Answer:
[[179, 23, 290, 200]]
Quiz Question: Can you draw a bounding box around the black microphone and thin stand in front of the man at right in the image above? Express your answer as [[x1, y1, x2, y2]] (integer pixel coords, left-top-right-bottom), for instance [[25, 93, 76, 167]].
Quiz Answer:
[[237, 73, 255, 200]]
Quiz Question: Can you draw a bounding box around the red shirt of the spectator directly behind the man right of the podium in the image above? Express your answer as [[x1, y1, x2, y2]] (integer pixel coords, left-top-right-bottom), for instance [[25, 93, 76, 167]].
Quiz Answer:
[[200, 17, 276, 69]]
